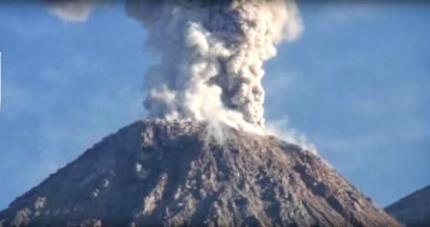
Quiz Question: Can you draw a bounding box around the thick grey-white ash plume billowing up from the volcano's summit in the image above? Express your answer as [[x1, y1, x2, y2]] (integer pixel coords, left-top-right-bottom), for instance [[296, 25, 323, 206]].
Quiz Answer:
[[43, 0, 301, 135]]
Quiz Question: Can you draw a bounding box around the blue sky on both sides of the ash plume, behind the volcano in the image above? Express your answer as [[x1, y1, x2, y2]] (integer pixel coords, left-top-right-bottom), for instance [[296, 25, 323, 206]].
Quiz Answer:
[[0, 3, 430, 209]]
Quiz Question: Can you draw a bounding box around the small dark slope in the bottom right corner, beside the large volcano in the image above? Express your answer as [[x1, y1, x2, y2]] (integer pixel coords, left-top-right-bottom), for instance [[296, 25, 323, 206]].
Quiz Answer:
[[385, 185, 430, 227]]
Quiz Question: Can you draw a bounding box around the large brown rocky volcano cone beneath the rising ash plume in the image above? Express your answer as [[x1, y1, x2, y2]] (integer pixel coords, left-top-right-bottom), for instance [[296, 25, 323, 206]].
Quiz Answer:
[[0, 121, 398, 226]]
